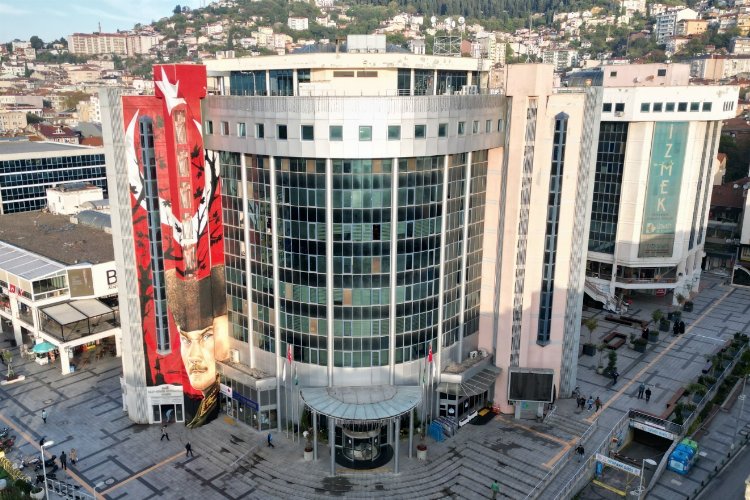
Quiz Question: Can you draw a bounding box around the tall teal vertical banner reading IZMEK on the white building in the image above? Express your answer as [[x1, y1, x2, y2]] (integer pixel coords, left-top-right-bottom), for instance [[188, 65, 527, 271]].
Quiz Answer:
[[638, 122, 688, 257]]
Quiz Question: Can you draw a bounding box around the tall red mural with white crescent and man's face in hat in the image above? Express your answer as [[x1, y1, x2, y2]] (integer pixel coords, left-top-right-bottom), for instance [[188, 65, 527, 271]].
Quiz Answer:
[[123, 64, 229, 428]]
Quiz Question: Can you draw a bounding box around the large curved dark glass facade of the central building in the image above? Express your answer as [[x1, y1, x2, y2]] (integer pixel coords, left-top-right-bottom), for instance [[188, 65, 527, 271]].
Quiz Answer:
[[219, 150, 488, 368]]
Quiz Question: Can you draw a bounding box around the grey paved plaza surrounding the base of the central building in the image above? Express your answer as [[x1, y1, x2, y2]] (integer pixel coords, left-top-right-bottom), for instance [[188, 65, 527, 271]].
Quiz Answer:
[[0, 278, 750, 499]]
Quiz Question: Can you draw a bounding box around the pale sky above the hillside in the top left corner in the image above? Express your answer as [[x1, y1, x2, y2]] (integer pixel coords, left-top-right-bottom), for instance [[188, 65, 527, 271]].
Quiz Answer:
[[0, 0, 203, 42]]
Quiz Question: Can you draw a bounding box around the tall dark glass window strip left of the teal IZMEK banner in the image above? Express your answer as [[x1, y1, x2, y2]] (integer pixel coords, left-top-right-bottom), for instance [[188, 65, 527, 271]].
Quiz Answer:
[[589, 122, 628, 254]]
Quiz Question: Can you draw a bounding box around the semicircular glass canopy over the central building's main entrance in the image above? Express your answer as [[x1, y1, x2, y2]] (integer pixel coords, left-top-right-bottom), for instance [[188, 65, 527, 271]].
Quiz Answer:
[[302, 385, 422, 422]]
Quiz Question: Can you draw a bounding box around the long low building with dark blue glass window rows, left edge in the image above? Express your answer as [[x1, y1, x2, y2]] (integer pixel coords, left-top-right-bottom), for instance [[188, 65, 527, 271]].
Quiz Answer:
[[0, 141, 107, 214]]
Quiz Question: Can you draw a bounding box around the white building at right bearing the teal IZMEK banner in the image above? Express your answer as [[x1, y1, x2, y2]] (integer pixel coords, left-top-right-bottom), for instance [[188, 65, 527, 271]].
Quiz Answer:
[[571, 64, 738, 310]]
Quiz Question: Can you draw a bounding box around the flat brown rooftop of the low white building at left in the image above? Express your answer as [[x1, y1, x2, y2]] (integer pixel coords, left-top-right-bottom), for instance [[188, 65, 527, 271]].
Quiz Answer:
[[0, 212, 115, 265]]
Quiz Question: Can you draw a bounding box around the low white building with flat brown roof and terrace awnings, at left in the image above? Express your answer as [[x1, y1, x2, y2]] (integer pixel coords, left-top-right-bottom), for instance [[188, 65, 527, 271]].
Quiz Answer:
[[0, 212, 121, 375]]
